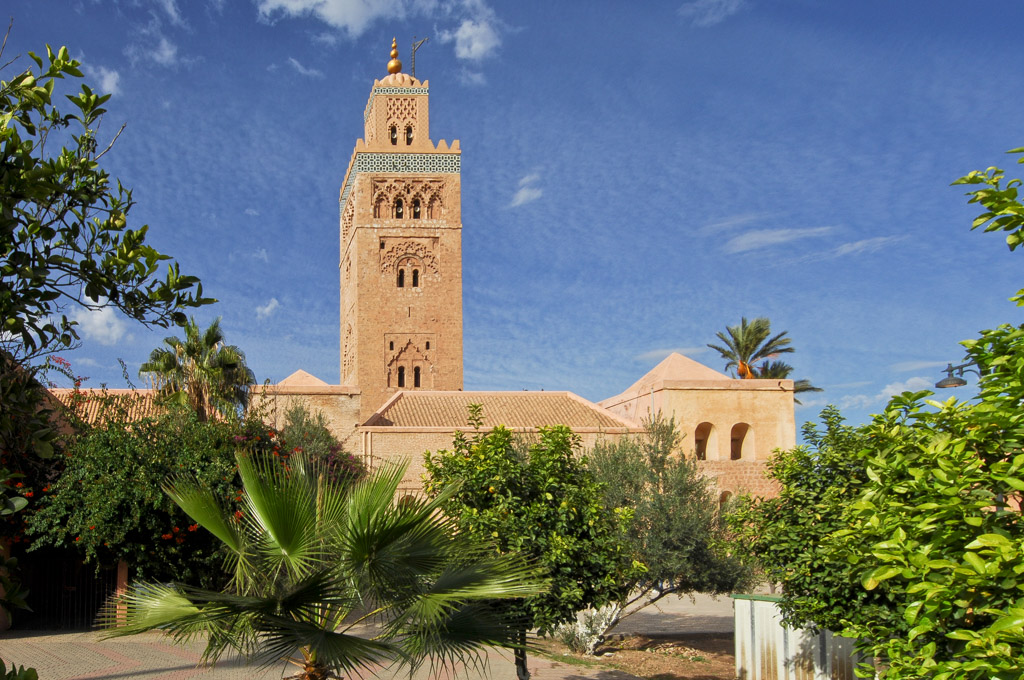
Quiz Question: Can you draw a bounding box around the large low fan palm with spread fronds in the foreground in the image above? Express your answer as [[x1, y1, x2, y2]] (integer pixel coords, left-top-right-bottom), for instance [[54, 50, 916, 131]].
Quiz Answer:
[[101, 454, 546, 680]]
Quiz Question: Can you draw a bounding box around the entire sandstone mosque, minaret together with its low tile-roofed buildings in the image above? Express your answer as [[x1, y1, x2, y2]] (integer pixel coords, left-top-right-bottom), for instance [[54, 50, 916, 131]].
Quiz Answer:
[[247, 42, 796, 499]]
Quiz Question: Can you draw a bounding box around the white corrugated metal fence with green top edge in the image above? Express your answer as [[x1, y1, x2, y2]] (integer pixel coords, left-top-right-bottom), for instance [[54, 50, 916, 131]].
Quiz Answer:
[[732, 595, 864, 680]]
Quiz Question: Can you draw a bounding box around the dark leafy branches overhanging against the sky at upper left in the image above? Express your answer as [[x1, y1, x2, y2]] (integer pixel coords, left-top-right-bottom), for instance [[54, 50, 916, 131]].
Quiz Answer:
[[0, 41, 212, 358]]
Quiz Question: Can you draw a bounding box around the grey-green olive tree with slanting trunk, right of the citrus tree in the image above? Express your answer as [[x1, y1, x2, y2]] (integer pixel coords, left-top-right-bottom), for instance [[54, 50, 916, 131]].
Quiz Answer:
[[590, 415, 751, 624]]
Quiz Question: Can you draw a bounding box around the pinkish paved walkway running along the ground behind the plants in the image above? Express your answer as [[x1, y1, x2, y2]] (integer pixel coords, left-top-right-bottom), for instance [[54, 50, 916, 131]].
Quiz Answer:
[[0, 597, 732, 680]]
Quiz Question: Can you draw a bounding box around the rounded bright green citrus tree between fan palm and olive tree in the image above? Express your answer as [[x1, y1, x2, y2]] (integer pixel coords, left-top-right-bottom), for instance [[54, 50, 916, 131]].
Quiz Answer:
[[425, 426, 637, 655]]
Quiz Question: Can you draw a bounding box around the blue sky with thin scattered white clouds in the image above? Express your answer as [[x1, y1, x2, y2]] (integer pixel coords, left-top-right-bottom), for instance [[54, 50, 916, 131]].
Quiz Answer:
[[3, 0, 1024, 430]]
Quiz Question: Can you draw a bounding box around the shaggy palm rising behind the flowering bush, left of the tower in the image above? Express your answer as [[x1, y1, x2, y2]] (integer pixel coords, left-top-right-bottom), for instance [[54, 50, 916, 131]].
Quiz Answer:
[[138, 317, 256, 421]]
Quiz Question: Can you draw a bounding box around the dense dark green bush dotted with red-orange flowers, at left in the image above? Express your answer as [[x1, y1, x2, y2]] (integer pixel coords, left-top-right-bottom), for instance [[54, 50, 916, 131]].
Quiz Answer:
[[28, 396, 240, 585]]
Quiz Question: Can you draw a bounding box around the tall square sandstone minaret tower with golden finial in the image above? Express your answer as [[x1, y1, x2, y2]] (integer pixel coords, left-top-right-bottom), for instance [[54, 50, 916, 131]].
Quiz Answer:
[[339, 42, 462, 421]]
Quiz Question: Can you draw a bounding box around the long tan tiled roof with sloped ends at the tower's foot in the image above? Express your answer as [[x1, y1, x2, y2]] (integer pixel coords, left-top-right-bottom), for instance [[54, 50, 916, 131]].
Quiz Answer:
[[366, 390, 635, 429]]
